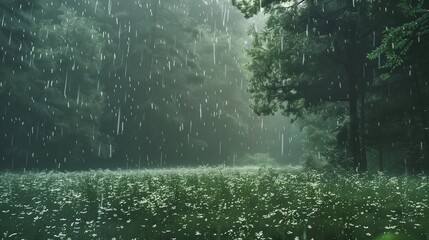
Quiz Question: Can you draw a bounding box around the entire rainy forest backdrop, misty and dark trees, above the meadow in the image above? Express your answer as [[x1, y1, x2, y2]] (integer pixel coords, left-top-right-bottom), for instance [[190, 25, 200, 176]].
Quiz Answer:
[[0, 0, 429, 173]]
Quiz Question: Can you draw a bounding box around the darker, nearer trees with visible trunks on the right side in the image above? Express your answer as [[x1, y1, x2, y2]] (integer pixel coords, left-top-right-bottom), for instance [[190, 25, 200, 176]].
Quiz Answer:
[[234, 0, 429, 173]]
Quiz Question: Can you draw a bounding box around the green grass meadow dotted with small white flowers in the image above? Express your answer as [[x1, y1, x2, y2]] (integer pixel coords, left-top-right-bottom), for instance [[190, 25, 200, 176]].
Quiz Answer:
[[0, 167, 429, 240]]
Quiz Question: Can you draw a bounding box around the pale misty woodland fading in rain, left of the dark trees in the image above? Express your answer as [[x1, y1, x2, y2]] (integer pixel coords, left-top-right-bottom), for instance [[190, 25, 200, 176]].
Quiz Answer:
[[0, 0, 300, 170]]
